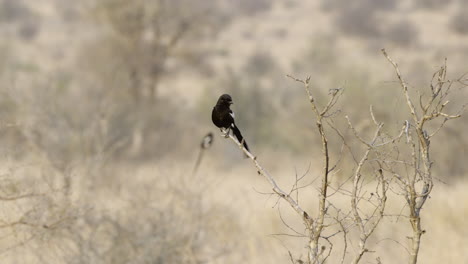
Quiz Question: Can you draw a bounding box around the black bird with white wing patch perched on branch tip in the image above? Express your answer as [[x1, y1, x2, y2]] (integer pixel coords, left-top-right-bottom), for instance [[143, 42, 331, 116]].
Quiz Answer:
[[211, 94, 250, 152]]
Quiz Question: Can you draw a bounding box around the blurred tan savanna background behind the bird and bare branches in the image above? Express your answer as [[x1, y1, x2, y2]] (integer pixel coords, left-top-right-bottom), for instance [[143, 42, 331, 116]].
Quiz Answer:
[[0, 0, 468, 263]]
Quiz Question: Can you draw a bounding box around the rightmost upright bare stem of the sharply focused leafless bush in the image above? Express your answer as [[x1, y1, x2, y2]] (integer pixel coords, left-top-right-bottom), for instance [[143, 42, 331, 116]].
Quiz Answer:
[[382, 49, 466, 264]]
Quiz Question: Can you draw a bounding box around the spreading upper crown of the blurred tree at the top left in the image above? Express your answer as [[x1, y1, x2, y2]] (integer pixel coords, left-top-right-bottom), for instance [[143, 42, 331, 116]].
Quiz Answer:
[[92, 0, 222, 102]]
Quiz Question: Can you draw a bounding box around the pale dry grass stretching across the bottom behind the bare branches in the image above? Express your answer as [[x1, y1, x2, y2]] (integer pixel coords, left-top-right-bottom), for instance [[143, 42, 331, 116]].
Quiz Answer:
[[0, 157, 468, 264]]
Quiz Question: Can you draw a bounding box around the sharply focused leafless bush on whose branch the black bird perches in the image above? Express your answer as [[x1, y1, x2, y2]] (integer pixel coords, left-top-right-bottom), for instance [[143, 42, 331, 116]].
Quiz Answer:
[[222, 50, 467, 264]]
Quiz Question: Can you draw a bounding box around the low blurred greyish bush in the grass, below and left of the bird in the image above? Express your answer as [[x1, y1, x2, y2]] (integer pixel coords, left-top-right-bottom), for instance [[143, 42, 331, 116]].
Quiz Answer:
[[57, 169, 242, 264]]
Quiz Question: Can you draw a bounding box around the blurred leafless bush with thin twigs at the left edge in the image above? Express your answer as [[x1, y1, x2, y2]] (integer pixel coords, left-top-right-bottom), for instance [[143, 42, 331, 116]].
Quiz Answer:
[[0, 154, 83, 261]]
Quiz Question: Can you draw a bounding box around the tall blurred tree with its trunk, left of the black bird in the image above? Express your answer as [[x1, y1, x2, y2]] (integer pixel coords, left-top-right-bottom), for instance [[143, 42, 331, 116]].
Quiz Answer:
[[59, 0, 234, 161]]
